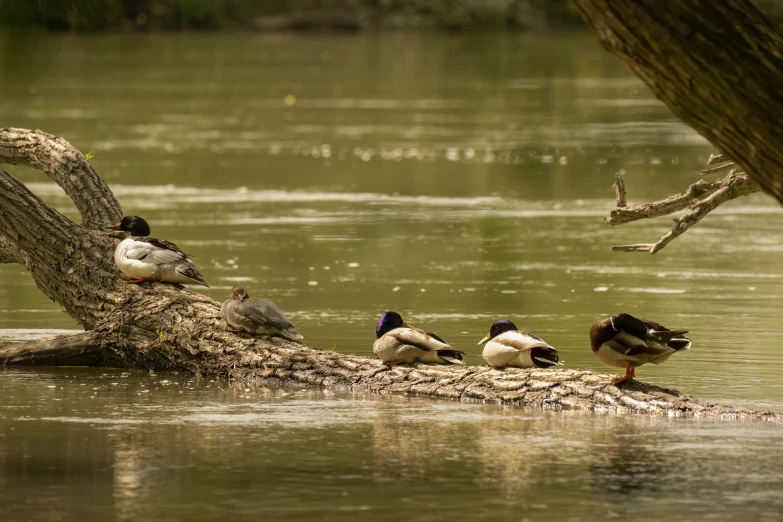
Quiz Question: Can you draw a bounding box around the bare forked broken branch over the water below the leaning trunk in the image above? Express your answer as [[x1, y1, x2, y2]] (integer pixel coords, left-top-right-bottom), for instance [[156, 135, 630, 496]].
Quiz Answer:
[[605, 160, 761, 254]]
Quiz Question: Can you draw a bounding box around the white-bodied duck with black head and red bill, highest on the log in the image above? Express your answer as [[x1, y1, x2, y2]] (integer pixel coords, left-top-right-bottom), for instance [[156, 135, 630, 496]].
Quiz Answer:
[[107, 216, 209, 287]]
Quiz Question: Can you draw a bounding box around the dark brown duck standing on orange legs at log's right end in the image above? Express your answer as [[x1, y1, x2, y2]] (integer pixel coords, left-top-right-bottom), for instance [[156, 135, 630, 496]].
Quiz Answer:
[[590, 313, 691, 385]]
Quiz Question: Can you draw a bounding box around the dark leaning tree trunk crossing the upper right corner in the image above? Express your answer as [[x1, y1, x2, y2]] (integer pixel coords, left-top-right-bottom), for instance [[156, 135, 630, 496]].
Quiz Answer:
[[574, 0, 783, 203]]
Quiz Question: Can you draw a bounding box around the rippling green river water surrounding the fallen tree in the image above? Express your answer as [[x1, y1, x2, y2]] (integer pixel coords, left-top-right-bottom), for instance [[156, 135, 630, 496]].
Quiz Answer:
[[0, 33, 783, 521]]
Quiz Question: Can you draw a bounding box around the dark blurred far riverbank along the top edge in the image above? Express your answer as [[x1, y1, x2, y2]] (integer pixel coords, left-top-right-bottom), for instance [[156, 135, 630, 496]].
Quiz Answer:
[[0, 0, 583, 31]]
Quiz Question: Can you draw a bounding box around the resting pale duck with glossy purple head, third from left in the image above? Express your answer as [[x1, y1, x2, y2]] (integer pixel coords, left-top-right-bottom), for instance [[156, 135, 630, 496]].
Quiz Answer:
[[372, 312, 465, 365]]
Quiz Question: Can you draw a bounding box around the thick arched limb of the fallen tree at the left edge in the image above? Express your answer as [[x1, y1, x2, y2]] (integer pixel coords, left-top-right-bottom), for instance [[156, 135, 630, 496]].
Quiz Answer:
[[0, 127, 122, 229]]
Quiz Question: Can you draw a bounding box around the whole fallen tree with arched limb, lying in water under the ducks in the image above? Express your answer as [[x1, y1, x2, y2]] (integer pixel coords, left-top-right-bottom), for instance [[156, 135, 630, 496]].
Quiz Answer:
[[0, 129, 780, 421]]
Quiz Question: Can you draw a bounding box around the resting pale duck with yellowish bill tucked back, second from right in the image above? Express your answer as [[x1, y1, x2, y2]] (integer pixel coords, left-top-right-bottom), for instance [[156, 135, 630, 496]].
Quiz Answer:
[[478, 319, 563, 368]]
